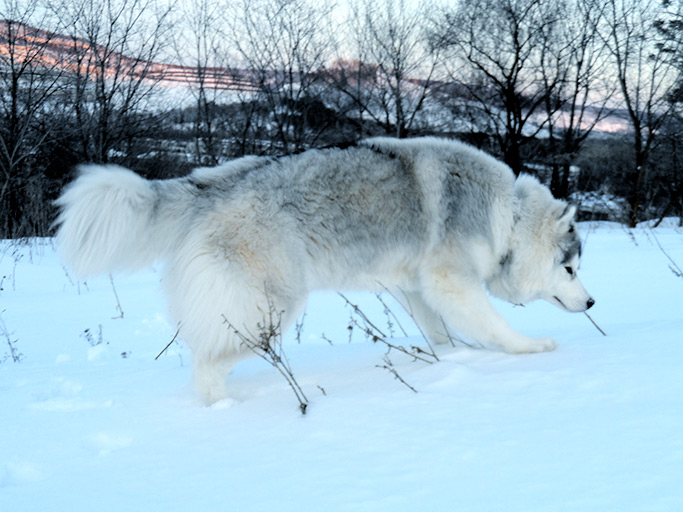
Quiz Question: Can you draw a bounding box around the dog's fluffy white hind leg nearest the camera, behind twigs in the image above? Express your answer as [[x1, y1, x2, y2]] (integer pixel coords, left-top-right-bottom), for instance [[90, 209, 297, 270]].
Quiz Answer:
[[164, 244, 303, 404]]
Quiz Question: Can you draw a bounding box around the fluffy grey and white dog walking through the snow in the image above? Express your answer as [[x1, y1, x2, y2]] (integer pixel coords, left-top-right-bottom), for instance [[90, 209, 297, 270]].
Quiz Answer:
[[56, 137, 594, 404]]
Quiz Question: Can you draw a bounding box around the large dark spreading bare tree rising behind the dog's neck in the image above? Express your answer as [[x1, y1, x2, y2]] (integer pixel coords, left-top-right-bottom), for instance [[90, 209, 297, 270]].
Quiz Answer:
[[433, 0, 560, 174]]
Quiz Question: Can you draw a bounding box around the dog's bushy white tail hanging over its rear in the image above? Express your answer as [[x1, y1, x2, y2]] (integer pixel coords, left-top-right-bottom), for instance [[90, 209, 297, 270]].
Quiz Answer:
[[56, 165, 162, 279]]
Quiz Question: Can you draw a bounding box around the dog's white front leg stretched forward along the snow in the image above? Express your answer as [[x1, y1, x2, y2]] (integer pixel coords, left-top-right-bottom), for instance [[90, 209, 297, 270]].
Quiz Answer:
[[423, 274, 557, 354]]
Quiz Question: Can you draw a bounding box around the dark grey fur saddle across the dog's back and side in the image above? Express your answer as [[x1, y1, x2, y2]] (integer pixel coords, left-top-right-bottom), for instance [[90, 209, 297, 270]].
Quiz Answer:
[[168, 138, 514, 263]]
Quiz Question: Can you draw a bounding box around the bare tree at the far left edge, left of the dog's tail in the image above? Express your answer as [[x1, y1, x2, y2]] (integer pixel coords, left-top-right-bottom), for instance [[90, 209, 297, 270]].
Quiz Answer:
[[0, 0, 61, 237]]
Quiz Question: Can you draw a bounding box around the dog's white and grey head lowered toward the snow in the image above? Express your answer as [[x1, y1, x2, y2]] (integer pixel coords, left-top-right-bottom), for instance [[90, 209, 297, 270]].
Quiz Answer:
[[489, 180, 595, 312]]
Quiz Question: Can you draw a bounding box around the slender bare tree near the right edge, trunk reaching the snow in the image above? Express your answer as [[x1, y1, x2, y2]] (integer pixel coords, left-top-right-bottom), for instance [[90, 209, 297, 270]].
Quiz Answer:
[[590, 0, 683, 226]]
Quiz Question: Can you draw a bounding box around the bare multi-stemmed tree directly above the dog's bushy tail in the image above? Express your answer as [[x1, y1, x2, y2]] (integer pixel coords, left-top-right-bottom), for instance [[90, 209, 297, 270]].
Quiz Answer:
[[53, 0, 170, 162]]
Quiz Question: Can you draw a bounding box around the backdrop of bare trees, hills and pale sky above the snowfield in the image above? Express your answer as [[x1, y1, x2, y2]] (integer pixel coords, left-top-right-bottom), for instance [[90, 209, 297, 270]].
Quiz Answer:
[[0, 0, 683, 238]]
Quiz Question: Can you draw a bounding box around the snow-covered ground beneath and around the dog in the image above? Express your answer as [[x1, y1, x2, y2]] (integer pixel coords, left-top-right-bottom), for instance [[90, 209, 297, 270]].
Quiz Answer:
[[0, 223, 683, 512]]
